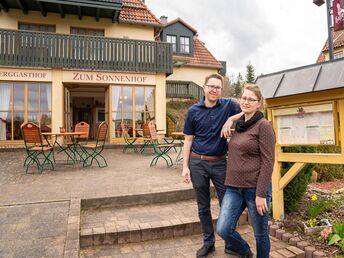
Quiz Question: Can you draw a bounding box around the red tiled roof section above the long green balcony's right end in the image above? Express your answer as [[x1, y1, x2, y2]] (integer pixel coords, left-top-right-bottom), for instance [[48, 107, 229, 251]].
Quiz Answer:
[[119, 0, 162, 27]]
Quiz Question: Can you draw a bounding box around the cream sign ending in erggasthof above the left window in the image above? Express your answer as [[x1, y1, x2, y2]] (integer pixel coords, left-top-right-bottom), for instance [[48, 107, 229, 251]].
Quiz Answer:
[[0, 68, 51, 82]]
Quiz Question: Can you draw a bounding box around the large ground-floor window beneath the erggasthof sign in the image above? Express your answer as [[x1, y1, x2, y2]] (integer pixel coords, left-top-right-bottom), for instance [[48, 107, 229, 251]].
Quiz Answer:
[[0, 82, 51, 141]]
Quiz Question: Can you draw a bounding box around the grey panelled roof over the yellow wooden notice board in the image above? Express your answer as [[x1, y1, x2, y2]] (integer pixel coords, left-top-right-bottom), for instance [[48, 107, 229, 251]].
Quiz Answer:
[[256, 58, 344, 99]]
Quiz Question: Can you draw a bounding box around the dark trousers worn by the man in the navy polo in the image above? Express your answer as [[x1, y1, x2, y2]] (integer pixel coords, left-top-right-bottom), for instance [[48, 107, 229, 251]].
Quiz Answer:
[[189, 157, 227, 245]]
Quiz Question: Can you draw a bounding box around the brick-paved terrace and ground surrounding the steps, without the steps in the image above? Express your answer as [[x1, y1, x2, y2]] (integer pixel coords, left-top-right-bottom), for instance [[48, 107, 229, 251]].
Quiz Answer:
[[0, 149, 300, 258]]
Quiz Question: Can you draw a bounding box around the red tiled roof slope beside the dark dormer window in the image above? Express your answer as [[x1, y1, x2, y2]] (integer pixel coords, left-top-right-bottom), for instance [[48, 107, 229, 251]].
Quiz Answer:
[[173, 36, 222, 69]]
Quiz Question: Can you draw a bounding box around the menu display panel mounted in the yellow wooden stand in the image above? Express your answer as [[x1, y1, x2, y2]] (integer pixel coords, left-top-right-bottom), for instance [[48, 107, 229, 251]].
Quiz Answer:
[[274, 103, 336, 145]]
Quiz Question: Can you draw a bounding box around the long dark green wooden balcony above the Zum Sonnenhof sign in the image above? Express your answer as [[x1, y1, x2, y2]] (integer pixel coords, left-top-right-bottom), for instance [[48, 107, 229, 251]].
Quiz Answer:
[[0, 29, 173, 74]]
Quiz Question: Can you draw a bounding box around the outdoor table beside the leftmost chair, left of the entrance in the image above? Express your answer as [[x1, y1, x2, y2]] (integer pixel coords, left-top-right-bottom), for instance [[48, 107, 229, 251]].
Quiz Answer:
[[42, 132, 87, 164]]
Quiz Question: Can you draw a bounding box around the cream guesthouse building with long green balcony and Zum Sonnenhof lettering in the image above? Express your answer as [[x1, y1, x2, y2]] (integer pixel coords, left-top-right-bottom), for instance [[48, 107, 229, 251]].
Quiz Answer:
[[0, 0, 173, 144]]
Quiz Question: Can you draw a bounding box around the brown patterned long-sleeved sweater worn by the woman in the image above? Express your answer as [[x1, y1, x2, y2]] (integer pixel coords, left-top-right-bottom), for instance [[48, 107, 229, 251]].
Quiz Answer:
[[225, 118, 275, 197]]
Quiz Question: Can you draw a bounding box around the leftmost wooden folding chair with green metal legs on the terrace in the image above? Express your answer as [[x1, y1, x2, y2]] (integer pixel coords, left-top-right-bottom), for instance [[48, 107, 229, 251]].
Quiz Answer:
[[21, 122, 54, 173]]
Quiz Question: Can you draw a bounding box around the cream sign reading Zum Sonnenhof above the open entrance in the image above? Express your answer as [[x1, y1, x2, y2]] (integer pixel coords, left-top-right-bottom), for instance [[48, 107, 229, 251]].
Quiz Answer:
[[62, 71, 155, 85]]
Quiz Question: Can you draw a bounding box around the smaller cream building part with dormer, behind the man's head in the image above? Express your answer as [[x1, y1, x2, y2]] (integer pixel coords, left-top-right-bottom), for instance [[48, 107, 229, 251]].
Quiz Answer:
[[158, 16, 226, 98]]
